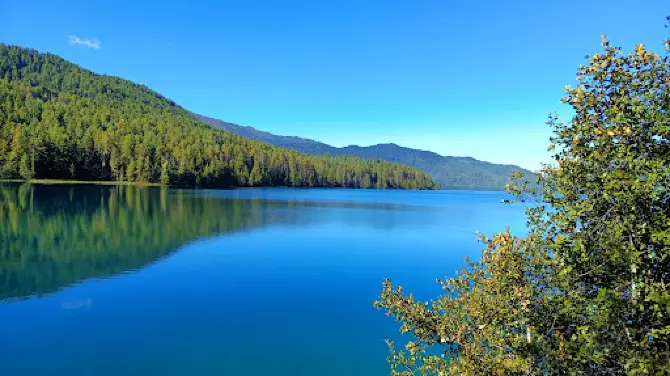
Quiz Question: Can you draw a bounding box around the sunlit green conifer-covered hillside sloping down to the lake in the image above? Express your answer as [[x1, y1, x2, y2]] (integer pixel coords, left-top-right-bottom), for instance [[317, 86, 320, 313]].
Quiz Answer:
[[0, 44, 436, 189]]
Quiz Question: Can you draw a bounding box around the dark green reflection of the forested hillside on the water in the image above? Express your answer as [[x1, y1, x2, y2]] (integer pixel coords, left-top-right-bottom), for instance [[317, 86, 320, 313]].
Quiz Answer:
[[0, 184, 276, 299]]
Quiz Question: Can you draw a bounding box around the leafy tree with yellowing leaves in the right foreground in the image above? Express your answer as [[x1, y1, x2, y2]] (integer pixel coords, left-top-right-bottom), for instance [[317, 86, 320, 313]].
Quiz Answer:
[[375, 31, 670, 375]]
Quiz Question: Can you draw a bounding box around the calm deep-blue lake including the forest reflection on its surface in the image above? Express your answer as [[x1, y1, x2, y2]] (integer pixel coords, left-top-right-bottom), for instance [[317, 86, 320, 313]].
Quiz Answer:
[[0, 183, 525, 376]]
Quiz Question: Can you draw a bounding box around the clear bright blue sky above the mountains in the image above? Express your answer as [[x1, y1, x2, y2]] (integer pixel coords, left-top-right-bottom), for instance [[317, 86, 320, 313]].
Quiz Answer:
[[0, 0, 670, 169]]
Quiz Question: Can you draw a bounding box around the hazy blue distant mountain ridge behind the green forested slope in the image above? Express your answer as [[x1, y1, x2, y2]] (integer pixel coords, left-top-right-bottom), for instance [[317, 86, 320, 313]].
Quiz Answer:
[[194, 114, 532, 190]]
